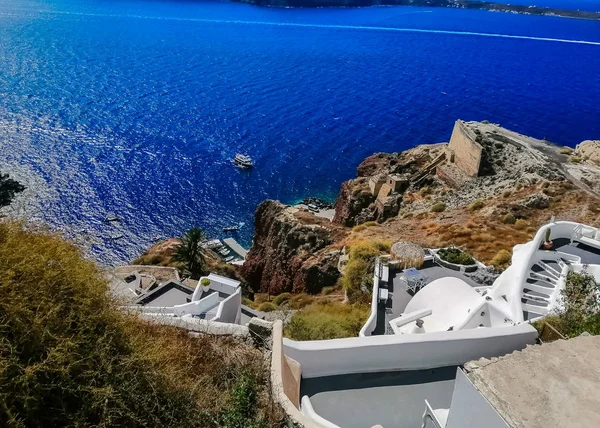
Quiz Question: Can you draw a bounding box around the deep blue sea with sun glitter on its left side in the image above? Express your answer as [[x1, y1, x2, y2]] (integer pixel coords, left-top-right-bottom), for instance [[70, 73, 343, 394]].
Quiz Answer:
[[0, 0, 600, 264]]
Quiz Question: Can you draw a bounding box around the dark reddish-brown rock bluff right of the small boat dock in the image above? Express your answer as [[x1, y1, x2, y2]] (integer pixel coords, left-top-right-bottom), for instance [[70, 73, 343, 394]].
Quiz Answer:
[[241, 200, 340, 295]]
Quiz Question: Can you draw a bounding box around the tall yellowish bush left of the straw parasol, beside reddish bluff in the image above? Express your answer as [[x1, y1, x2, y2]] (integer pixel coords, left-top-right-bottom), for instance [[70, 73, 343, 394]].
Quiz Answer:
[[340, 241, 391, 302]]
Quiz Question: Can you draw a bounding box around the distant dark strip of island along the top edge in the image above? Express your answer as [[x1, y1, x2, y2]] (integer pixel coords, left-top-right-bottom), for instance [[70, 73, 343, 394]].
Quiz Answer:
[[235, 0, 600, 20]]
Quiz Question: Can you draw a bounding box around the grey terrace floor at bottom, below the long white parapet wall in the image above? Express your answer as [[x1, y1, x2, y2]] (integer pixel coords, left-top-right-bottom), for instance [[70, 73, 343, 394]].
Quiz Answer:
[[300, 366, 456, 428]]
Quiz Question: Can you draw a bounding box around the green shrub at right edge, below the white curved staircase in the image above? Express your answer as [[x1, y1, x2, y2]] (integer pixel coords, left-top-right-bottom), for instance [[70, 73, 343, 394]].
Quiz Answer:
[[534, 272, 600, 337]]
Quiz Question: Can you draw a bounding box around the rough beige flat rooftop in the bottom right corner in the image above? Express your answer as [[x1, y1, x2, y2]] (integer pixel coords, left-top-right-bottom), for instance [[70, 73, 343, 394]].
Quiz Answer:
[[465, 336, 600, 428]]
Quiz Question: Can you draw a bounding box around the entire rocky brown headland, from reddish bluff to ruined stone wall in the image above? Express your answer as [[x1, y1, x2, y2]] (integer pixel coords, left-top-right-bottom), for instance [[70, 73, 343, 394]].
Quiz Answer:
[[242, 122, 600, 294]]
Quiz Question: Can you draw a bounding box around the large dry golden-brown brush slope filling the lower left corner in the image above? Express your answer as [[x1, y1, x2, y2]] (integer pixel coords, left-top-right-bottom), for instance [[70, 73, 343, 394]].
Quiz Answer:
[[0, 223, 281, 427]]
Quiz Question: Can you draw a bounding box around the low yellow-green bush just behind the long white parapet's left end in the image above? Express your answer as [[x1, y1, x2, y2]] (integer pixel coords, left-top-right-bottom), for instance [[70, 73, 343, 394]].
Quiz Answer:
[[285, 302, 370, 340]]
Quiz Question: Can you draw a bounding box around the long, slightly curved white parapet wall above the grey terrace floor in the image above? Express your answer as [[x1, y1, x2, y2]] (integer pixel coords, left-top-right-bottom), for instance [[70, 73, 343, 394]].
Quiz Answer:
[[283, 324, 537, 378]]
